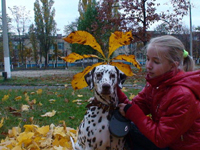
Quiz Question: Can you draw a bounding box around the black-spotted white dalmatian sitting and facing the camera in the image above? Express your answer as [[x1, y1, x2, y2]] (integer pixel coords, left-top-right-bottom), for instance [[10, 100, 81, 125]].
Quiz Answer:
[[75, 65, 126, 150]]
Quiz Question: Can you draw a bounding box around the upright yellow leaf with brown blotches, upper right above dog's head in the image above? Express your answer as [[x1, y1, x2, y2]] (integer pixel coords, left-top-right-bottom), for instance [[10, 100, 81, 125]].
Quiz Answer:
[[108, 31, 133, 58]]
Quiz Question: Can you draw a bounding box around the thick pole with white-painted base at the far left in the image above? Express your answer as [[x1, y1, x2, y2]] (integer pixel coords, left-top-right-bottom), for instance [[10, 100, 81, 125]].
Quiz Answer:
[[1, 0, 11, 78]]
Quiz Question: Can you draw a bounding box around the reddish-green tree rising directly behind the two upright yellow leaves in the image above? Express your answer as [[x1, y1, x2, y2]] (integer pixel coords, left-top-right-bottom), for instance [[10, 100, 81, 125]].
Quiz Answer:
[[92, 0, 121, 56]]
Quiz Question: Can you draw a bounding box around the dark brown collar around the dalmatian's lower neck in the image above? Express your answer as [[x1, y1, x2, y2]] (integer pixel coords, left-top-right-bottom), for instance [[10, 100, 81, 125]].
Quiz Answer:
[[86, 98, 116, 113]]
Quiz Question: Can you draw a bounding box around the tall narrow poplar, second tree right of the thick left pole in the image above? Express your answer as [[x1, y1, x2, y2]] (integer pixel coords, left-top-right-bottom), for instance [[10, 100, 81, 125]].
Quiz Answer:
[[34, 0, 56, 67]]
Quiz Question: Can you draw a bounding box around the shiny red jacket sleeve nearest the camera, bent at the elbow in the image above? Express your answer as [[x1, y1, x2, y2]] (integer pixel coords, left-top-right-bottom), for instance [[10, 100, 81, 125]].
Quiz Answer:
[[126, 87, 199, 148]]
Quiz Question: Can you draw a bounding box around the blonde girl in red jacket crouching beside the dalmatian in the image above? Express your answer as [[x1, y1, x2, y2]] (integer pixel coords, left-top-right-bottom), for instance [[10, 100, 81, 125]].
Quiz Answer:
[[118, 35, 200, 150]]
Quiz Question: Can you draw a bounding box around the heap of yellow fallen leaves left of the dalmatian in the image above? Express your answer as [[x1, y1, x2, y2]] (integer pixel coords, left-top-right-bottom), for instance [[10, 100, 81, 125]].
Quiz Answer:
[[0, 123, 77, 150]]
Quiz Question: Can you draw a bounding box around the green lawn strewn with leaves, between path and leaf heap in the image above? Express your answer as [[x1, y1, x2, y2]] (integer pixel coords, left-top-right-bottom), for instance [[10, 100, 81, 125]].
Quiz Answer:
[[0, 88, 139, 139]]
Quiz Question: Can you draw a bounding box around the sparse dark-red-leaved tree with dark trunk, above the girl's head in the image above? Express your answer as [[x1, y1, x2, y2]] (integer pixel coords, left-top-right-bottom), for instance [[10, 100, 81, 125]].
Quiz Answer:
[[120, 0, 189, 45]]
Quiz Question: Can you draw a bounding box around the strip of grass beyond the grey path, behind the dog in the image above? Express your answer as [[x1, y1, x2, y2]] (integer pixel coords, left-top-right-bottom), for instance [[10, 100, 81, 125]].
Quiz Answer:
[[0, 67, 145, 86]]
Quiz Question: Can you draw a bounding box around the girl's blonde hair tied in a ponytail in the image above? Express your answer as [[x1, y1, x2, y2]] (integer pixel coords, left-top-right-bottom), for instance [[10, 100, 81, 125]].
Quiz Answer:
[[147, 35, 195, 71]]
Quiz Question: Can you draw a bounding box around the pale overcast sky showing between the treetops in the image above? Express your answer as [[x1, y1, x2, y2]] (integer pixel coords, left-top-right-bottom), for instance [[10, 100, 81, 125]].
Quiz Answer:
[[0, 0, 200, 33]]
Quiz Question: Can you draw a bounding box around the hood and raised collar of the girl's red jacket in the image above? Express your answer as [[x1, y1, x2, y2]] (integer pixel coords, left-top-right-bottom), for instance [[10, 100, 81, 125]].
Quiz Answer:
[[146, 70, 200, 99]]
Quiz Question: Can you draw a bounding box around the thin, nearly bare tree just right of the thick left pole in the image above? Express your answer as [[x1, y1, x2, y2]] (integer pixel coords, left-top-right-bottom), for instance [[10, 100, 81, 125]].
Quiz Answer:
[[9, 6, 30, 63]]
